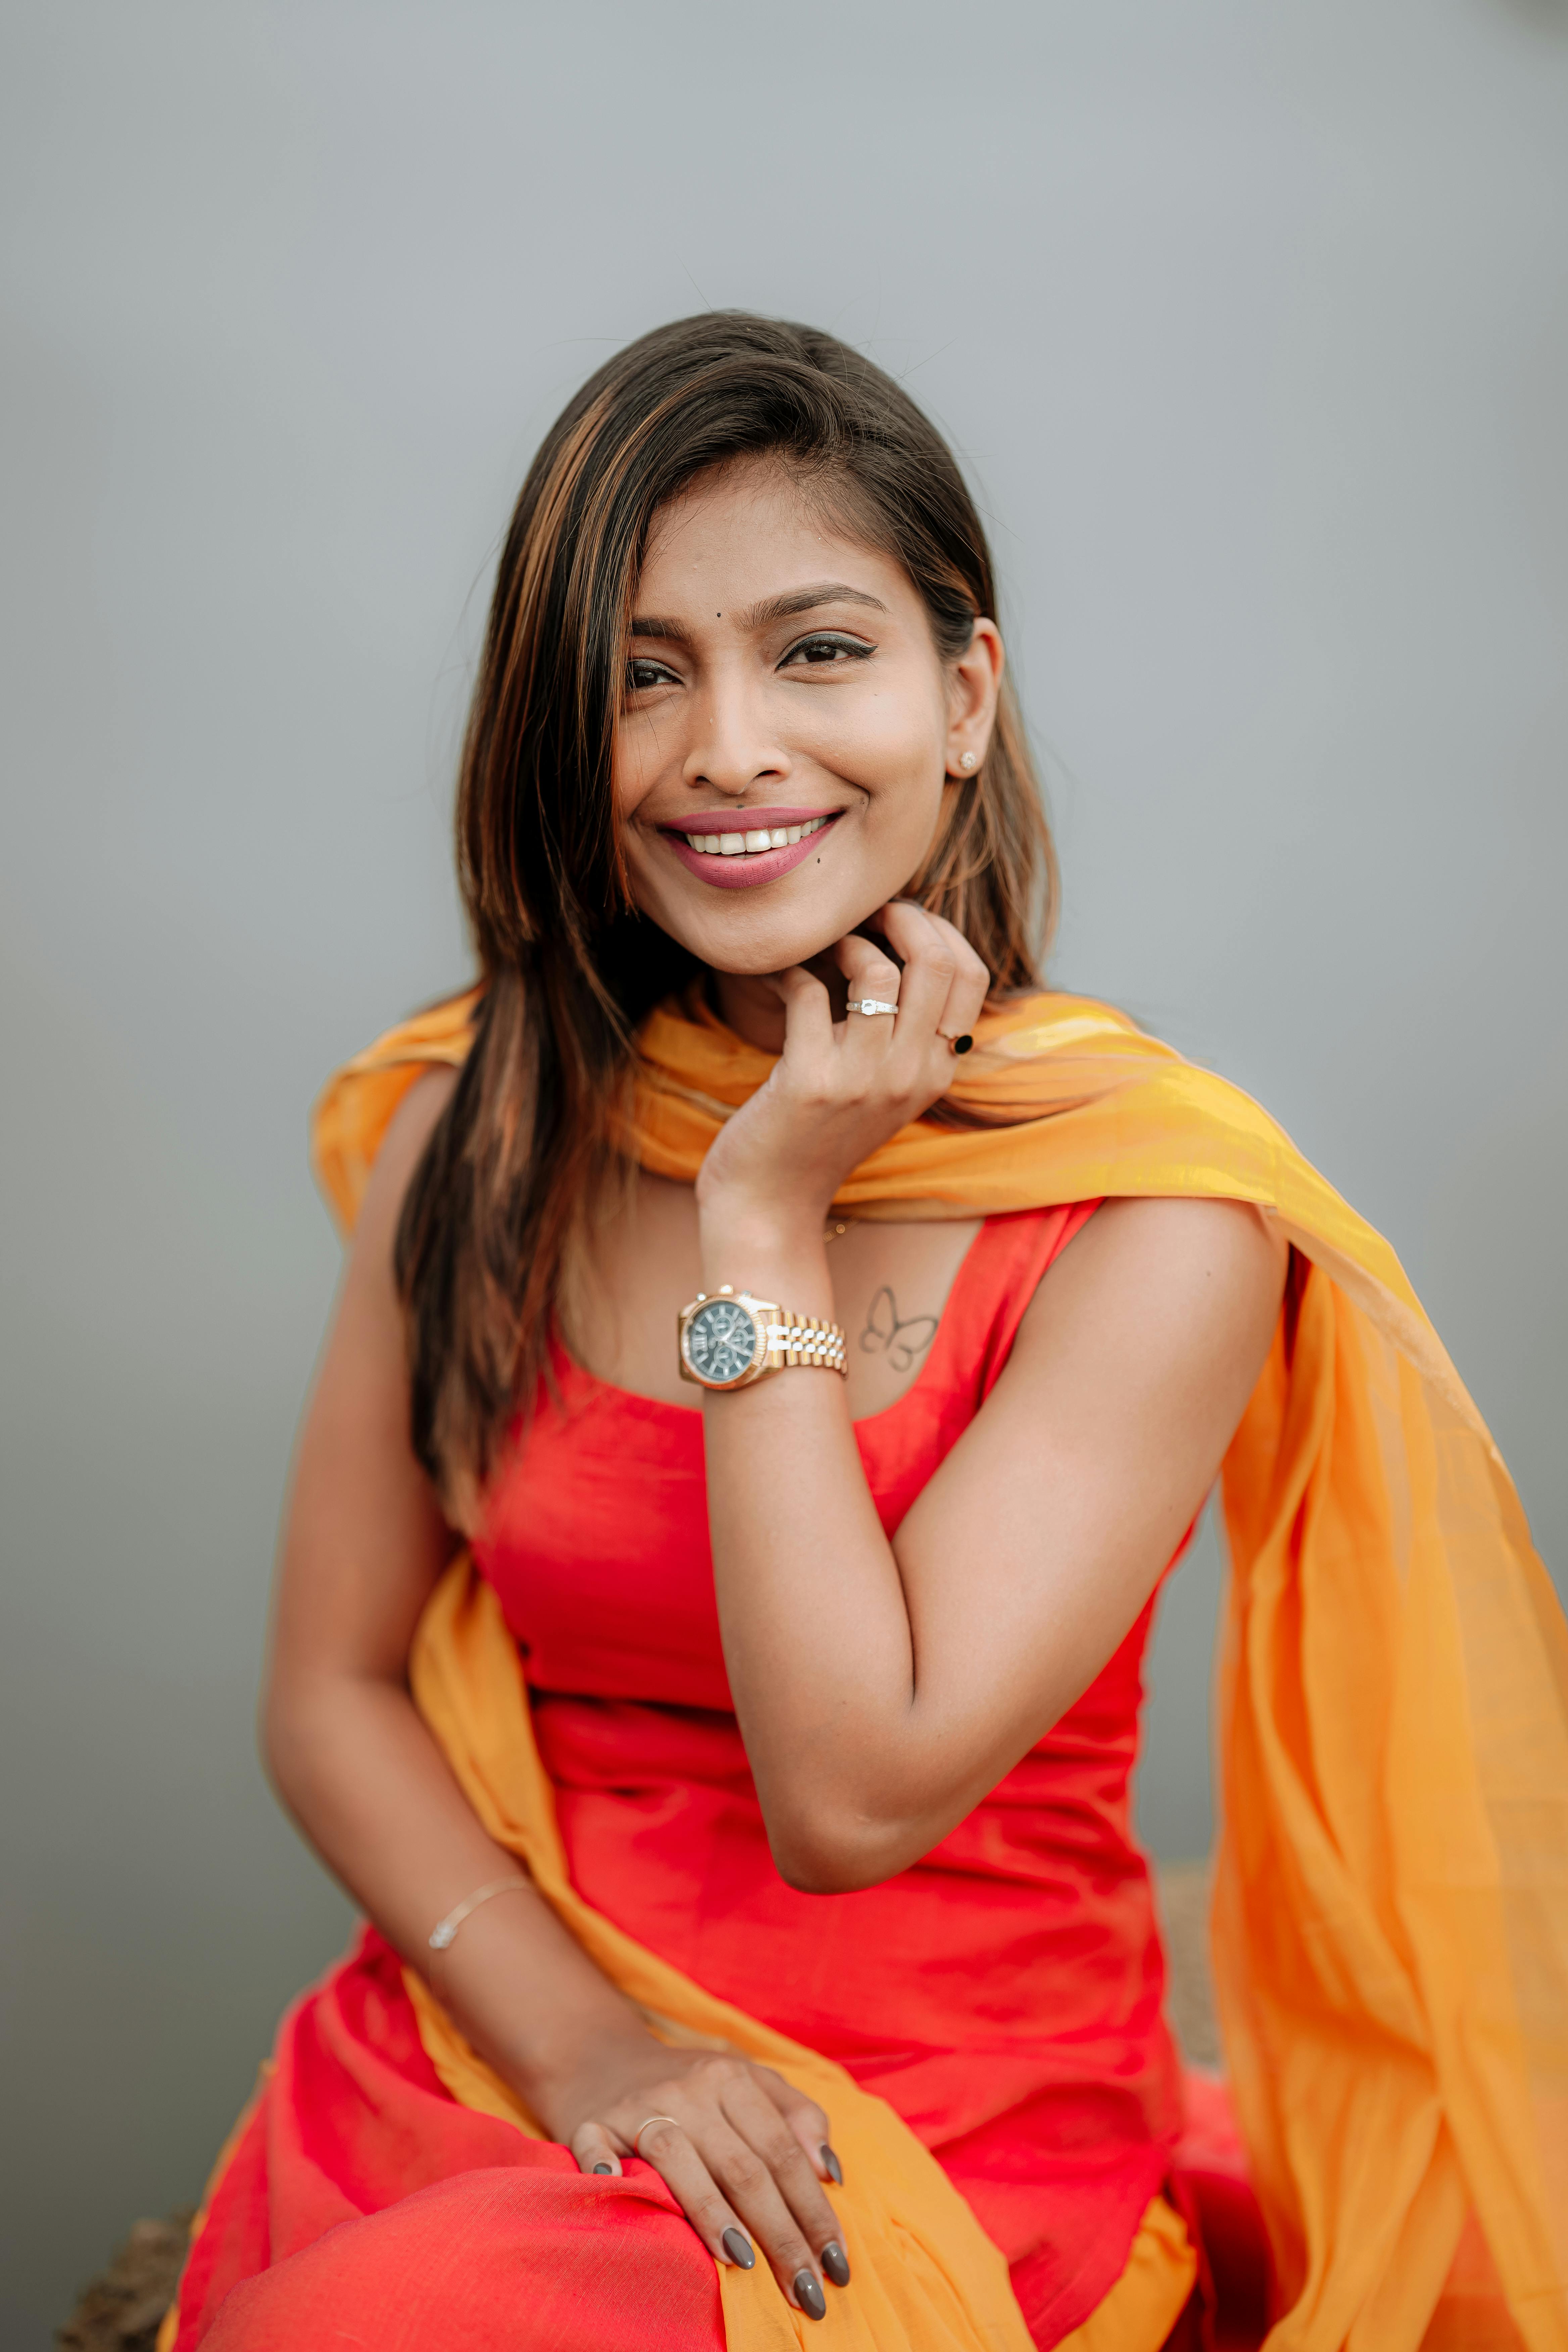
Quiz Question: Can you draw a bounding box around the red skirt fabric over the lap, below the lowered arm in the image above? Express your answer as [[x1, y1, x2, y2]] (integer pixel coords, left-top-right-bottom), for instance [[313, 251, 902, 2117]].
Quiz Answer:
[[174, 1933, 724, 2352]]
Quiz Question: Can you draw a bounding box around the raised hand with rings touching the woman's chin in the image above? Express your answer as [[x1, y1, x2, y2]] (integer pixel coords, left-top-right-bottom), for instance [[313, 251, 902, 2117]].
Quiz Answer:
[[696, 898, 990, 1230]]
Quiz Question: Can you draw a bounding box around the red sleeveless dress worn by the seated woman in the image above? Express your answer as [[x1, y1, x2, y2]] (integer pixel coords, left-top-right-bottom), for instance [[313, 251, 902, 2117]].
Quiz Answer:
[[176, 1204, 1222, 2352]]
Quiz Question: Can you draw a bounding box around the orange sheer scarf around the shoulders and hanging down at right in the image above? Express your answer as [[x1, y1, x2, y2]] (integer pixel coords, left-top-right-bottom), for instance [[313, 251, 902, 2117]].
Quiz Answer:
[[315, 995, 1568, 2352]]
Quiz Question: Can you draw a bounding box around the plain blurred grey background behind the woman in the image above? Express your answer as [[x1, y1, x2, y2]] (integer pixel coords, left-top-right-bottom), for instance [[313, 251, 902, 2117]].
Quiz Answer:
[[0, 0, 1568, 2347]]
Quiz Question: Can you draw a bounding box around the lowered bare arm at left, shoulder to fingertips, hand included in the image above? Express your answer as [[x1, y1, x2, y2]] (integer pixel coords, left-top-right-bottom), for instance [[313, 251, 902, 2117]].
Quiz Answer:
[[261, 1075, 846, 2310]]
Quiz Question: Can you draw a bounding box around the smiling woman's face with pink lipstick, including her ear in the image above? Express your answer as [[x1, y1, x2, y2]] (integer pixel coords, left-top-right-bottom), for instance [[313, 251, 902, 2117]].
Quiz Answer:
[[616, 463, 1001, 974]]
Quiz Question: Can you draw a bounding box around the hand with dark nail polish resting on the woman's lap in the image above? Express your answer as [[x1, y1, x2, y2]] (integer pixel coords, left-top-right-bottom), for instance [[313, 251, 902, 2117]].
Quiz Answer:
[[541, 2032, 849, 2319]]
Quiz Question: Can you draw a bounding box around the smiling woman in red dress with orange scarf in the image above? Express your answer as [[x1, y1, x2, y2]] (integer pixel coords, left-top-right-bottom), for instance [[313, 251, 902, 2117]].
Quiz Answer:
[[164, 317, 1568, 2352]]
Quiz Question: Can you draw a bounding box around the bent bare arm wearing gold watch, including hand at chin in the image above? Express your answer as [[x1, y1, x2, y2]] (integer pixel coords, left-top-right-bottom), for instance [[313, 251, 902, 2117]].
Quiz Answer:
[[698, 908, 1286, 1891]]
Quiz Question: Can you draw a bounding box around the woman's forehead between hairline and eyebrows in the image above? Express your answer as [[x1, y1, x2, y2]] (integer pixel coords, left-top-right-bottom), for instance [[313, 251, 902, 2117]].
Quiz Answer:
[[637, 459, 919, 616]]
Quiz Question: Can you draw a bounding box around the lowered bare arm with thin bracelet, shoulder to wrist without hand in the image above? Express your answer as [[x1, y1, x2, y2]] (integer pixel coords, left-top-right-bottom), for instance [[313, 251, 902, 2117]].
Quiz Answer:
[[263, 1075, 635, 2105]]
